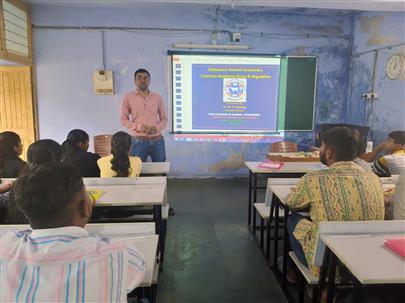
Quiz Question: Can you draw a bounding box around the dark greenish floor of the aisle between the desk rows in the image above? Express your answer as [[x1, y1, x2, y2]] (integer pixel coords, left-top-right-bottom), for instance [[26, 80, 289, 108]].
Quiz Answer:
[[157, 179, 286, 303]]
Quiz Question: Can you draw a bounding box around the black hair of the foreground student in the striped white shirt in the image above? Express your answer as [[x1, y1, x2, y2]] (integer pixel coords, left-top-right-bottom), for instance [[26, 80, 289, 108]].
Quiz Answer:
[[12, 162, 84, 227]]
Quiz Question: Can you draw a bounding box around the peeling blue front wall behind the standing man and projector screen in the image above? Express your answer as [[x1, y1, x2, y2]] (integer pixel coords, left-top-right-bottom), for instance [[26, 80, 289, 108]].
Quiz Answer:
[[32, 5, 352, 177]]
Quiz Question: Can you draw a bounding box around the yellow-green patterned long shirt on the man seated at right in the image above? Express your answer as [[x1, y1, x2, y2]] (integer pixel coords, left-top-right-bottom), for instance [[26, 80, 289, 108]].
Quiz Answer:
[[286, 162, 384, 275]]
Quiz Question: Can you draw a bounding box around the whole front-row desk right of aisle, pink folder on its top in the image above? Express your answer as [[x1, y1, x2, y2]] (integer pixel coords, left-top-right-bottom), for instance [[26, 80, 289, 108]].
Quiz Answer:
[[245, 162, 326, 232]]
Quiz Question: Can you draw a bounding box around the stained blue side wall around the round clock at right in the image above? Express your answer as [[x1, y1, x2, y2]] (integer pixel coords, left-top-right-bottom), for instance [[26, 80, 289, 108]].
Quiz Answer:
[[346, 12, 405, 143]]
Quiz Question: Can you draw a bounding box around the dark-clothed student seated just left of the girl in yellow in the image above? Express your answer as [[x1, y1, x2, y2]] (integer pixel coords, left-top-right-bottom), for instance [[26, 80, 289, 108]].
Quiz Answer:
[[62, 129, 100, 177]]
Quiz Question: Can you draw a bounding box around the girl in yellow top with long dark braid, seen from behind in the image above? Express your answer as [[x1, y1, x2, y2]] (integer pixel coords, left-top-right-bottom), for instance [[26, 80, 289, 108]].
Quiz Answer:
[[97, 132, 142, 178]]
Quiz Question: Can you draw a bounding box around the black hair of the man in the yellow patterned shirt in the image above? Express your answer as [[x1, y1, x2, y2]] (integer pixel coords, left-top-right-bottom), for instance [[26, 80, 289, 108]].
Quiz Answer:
[[322, 127, 360, 162]]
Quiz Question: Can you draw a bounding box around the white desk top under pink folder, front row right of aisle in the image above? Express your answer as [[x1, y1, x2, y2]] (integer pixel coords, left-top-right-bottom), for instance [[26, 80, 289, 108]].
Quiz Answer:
[[245, 162, 326, 174]]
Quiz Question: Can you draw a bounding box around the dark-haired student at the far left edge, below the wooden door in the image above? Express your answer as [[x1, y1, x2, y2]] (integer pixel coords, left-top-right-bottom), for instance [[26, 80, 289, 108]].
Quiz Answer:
[[0, 131, 27, 178]]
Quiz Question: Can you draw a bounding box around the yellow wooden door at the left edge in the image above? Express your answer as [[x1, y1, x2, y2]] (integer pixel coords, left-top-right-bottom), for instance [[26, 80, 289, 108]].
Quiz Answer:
[[0, 66, 36, 159]]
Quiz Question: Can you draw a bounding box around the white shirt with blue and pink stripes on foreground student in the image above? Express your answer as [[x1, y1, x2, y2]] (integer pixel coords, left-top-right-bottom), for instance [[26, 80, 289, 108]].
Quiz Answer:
[[0, 226, 146, 302]]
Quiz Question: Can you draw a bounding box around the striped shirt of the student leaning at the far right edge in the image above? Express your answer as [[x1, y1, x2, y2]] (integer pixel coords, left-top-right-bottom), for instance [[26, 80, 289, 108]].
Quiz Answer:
[[373, 149, 405, 177]]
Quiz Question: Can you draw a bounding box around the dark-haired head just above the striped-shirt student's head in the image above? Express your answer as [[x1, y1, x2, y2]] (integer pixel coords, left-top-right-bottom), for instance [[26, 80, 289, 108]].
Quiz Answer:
[[27, 139, 62, 166]]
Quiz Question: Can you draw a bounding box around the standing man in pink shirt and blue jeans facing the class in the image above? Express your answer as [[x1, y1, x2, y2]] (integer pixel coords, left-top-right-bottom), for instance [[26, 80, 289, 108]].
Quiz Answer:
[[121, 68, 167, 162]]
